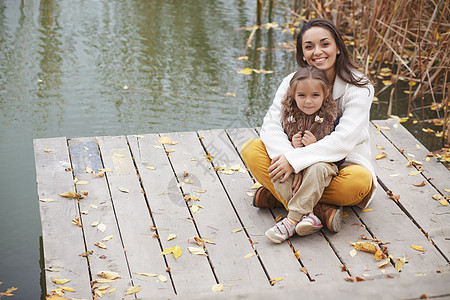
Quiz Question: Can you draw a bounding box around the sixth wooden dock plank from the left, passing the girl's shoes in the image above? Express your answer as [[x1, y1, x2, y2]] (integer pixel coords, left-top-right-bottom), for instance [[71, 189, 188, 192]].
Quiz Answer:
[[199, 130, 309, 286]]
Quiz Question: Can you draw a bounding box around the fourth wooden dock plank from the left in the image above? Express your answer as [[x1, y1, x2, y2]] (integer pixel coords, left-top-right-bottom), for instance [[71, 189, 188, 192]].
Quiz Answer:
[[128, 134, 216, 295]]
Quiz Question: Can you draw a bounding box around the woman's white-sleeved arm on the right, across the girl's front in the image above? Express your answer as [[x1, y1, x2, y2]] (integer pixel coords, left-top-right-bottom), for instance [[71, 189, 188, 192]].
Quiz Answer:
[[284, 85, 374, 173]]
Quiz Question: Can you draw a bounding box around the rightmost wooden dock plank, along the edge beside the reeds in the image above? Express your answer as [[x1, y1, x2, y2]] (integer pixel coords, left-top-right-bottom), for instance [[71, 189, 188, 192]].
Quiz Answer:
[[373, 120, 450, 195]]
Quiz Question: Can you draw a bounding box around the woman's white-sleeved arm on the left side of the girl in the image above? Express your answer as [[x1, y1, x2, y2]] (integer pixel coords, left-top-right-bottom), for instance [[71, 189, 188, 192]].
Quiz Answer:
[[260, 73, 294, 159]]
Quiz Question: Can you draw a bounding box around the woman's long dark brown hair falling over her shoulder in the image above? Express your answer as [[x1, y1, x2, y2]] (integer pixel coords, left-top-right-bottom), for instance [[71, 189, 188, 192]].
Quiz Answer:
[[297, 18, 370, 86]]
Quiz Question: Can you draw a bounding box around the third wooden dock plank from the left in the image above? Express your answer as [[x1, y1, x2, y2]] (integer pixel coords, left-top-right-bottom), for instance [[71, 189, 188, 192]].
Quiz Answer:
[[97, 136, 174, 298]]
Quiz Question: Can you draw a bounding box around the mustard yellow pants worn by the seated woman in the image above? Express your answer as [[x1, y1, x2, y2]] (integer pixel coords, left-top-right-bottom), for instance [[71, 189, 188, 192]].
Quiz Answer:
[[241, 139, 372, 209]]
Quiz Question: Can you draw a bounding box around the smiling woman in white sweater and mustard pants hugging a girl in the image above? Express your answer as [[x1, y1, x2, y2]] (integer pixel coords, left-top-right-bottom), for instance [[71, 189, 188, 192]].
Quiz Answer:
[[241, 19, 377, 232]]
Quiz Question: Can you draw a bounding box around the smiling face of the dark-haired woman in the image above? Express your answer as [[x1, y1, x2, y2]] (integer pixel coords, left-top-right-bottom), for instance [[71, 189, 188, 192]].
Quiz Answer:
[[302, 27, 340, 78]]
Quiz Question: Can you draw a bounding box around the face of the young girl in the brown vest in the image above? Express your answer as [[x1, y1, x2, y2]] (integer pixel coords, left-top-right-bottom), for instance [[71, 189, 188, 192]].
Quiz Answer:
[[295, 79, 328, 115]]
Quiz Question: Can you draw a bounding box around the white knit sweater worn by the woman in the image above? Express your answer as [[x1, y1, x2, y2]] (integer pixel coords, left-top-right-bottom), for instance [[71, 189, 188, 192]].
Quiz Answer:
[[261, 73, 377, 206]]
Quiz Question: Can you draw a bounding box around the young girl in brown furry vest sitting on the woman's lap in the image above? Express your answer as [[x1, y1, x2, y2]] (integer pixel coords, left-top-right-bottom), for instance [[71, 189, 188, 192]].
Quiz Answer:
[[266, 66, 338, 243]]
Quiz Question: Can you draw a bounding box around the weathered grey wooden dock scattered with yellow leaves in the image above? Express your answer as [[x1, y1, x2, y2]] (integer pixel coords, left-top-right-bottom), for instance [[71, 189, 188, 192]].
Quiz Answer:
[[34, 120, 450, 299]]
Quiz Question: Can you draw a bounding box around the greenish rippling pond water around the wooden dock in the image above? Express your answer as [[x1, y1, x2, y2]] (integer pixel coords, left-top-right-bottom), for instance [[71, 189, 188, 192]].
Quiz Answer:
[[0, 0, 437, 299]]
